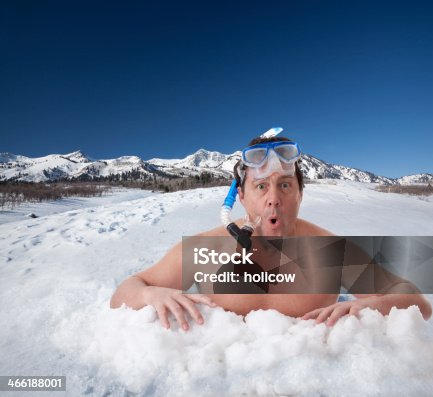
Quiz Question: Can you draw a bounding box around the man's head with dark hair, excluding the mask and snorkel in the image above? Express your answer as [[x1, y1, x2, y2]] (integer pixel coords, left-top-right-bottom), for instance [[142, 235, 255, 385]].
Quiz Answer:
[[234, 137, 304, 236]]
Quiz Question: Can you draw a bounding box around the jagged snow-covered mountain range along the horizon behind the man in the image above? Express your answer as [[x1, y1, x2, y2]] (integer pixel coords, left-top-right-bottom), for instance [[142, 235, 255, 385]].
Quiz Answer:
[[0, 149, 433, 184]]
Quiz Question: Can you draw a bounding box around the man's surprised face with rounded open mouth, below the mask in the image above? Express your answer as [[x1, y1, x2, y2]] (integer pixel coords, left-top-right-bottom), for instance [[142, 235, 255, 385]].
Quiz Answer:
[[238, 170, 302, 236]]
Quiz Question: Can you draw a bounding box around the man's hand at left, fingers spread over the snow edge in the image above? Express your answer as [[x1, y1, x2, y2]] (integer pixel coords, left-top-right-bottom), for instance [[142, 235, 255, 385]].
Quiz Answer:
[[144, 286, 217, 331]]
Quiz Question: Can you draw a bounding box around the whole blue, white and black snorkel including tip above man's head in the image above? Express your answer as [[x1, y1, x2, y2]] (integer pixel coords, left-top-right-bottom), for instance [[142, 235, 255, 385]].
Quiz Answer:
[[220, 127, 283, 251]]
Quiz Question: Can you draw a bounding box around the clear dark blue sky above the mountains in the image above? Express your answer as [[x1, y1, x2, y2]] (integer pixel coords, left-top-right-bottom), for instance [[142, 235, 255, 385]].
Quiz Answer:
[[0, 0, 433, 177]]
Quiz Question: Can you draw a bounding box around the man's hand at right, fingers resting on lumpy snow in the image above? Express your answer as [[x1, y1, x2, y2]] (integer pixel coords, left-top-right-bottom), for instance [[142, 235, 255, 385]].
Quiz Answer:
[[302, 296, 382, 327]]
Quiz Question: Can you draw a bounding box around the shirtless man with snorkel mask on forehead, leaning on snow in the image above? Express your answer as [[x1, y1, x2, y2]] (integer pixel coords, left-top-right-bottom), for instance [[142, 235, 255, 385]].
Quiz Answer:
[[111, 136, 432, 330]]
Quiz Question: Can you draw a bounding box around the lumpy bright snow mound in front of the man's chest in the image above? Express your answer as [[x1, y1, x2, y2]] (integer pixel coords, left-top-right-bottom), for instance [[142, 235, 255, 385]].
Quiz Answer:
[[52, 302, 433, 396]]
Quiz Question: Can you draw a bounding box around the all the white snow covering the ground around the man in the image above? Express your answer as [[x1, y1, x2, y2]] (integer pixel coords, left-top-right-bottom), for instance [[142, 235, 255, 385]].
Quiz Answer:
[[0, 181, 433, 396]]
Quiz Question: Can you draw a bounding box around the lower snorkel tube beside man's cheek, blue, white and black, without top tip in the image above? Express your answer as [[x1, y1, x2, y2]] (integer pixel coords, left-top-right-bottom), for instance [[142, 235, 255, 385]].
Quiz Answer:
[[220, 179, 255, 251]]
